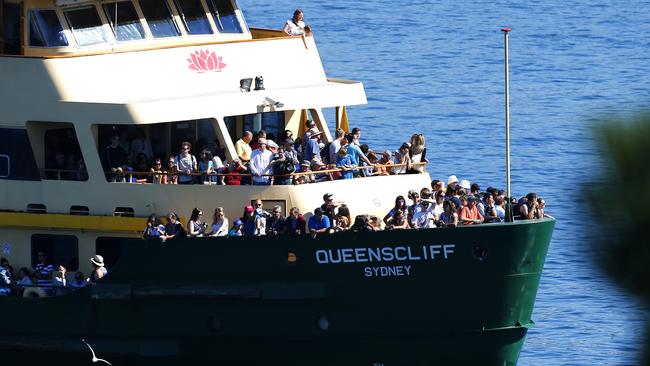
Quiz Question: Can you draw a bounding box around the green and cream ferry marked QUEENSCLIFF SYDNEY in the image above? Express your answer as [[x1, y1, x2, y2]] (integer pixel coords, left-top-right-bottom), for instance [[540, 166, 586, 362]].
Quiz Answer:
[[0, 0, 555, 366]]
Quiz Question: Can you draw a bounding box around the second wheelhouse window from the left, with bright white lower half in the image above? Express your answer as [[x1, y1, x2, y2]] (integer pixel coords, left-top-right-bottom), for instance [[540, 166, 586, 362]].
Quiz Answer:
[[64, 5, 108, 46]]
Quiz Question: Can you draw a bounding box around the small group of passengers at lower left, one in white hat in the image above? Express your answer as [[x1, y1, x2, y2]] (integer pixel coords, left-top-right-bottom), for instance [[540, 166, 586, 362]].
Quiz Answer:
[[0, 251, 108, 297]]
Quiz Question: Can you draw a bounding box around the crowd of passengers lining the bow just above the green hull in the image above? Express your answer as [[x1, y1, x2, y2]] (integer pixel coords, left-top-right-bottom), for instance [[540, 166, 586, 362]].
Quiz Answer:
[[143, 175, 546, 241]]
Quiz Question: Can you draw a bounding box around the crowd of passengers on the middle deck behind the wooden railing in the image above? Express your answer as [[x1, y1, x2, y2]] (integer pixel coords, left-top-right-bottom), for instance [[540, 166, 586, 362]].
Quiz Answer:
[[100, 120, 426, 185]]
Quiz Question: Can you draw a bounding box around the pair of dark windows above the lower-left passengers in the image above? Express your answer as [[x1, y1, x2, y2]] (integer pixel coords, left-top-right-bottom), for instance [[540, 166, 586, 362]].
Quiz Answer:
[[31, 234, 121, 271]]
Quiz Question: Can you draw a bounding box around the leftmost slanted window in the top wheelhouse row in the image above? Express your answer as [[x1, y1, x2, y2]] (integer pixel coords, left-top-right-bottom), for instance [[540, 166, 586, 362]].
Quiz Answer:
[[29, 10, 68, 47]]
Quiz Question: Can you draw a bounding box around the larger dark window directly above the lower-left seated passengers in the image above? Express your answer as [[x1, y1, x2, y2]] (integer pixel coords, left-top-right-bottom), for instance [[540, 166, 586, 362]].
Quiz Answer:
[[32, 234, 79, 271]]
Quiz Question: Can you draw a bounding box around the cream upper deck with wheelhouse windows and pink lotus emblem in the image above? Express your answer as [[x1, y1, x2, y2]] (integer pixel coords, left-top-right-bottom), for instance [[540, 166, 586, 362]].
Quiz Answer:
[[0, 0, 366, 125]]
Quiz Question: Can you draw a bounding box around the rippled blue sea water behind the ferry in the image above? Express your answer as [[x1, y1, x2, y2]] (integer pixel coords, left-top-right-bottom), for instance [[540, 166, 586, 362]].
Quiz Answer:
[[239, 0, 650, 366]]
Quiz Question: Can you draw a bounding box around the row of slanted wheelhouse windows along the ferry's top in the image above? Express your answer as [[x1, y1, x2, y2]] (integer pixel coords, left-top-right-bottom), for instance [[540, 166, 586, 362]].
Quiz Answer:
[[29, 0, 243, 47]]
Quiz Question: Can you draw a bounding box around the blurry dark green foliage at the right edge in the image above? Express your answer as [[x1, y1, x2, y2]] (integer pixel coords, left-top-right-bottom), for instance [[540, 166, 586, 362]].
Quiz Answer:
[[588, 114, 650, 366]]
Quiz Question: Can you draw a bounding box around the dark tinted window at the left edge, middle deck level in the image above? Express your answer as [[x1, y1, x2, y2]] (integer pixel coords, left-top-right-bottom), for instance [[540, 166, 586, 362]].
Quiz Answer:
[[0, 128, 40, 180]]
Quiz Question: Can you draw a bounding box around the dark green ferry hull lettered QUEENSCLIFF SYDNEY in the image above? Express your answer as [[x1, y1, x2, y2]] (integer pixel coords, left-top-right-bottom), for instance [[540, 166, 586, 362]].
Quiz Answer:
[[0, 219, 555, 366]]
